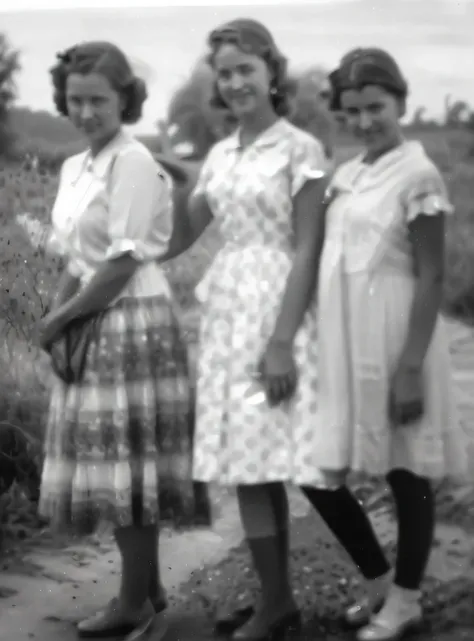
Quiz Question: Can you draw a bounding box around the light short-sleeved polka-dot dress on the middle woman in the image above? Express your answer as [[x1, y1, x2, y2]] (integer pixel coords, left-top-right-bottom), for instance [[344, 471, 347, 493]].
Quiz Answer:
[[193, 119, 326, 484]]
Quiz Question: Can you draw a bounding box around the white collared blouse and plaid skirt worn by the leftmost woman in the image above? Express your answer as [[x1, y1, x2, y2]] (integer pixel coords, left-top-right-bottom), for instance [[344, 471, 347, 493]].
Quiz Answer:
[[39, 131, 192, 532]]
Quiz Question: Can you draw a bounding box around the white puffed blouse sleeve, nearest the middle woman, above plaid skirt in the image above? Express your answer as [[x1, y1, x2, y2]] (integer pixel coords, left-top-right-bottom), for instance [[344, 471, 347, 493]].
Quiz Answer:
[[105, 149, 173, 262]]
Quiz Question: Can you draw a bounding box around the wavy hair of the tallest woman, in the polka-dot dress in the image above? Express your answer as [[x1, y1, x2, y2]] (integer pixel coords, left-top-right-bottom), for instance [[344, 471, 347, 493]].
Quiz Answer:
[[207, 18, 295, 116]]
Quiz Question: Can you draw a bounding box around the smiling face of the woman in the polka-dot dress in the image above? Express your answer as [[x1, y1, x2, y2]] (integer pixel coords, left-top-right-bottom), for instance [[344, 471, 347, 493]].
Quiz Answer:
[[214, 44, 271, 119]]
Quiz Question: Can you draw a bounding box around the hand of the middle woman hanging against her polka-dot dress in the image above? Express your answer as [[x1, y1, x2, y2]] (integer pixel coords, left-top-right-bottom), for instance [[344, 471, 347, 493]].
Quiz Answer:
[[258, 340, 298, 406]]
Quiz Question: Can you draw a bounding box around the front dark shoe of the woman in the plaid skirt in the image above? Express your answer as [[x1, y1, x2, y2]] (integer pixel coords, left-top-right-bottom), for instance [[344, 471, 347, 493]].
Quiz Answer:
[[77, 599, 155, 639]]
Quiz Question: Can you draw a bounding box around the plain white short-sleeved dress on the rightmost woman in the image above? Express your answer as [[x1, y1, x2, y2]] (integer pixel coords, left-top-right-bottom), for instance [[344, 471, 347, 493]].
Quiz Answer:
[[315, 142, 467, 478]]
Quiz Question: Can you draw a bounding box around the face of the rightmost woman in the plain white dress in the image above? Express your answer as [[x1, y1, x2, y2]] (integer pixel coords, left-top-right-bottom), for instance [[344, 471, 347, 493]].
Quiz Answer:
[[341, 85, 404, 154]]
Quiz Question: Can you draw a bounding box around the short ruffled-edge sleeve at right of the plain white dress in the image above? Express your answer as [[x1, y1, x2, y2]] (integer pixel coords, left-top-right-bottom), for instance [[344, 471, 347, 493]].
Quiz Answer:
[[402, 163, 454, 223]]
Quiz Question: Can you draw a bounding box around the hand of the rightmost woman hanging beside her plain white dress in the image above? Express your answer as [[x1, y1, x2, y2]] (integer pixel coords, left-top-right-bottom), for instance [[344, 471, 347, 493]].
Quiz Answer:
[[389, 359, 424, 426]]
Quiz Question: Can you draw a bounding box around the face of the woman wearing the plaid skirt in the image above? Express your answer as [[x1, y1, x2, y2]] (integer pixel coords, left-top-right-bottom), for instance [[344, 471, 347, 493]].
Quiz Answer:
[[66, 73, 123, 145]]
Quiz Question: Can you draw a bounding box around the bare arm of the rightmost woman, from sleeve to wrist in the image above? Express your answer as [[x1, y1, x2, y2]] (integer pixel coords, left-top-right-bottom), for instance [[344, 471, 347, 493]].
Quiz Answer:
[[401, 213, 445, 368]]
